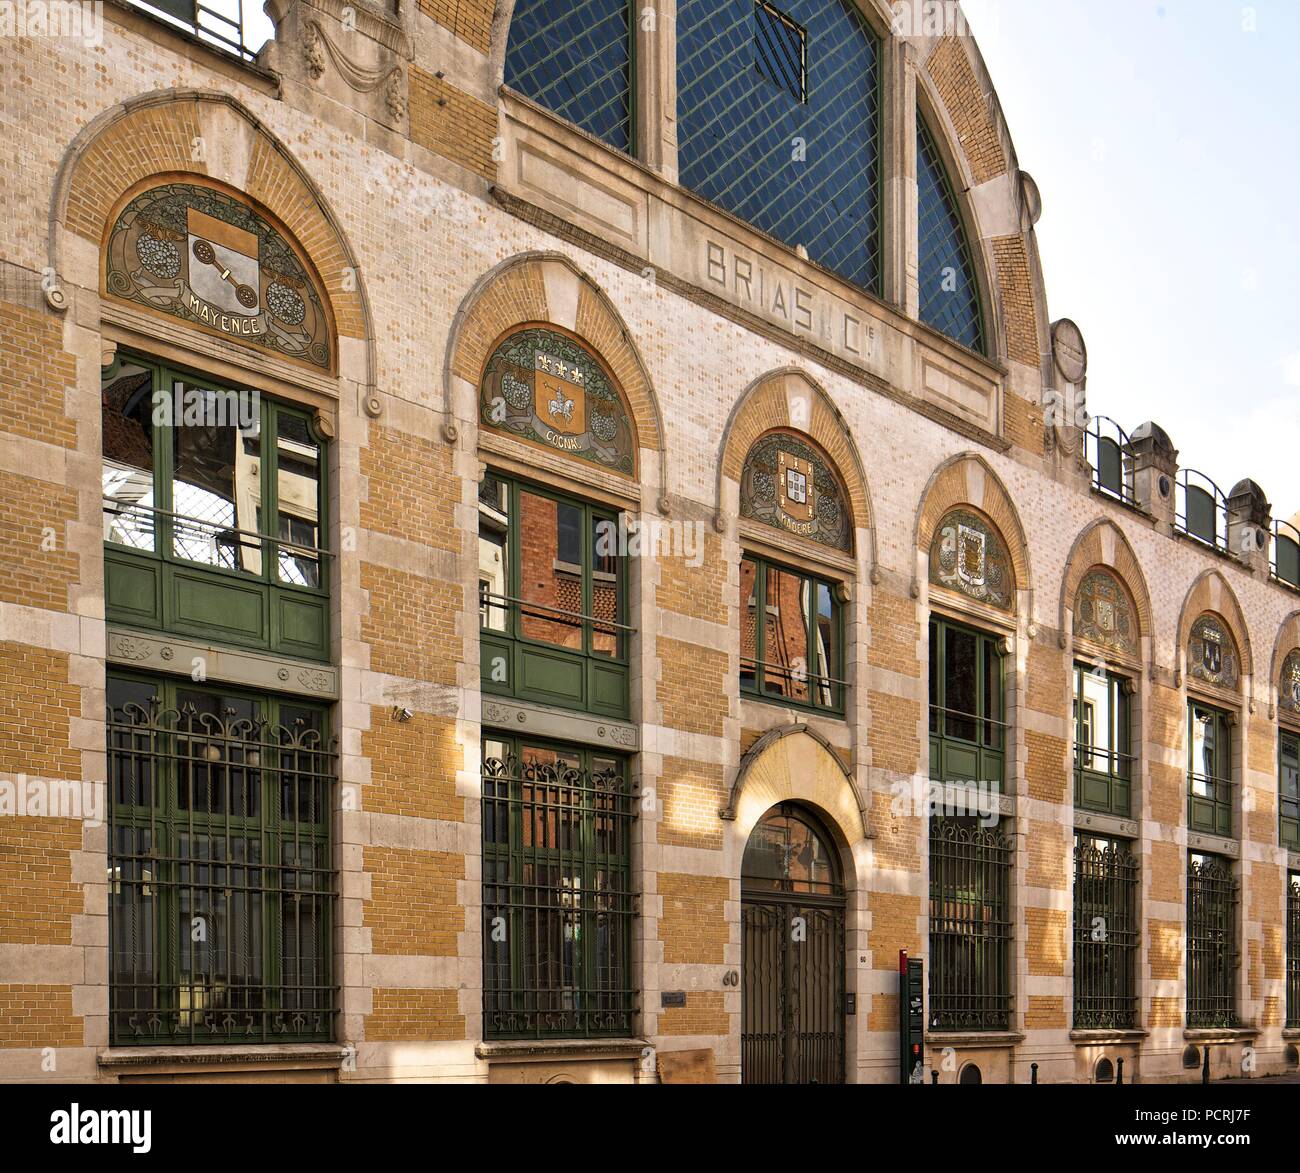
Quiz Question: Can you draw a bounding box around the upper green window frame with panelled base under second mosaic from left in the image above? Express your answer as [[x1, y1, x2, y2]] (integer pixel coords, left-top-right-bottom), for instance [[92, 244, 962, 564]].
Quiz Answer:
[[478, 471, 634, 719]]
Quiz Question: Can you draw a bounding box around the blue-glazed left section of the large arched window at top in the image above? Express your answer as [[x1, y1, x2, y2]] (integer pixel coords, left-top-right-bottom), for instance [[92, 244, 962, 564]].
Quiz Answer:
[[506, 0, 632, 151]]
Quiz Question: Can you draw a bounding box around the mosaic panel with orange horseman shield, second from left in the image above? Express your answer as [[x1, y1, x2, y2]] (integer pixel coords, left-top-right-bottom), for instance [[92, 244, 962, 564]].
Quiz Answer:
[[478, 326, 636, 476]]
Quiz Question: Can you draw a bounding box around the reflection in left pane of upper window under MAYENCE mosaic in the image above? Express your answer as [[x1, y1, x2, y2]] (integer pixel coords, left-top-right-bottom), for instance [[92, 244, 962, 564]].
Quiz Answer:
[[100, 362, 156, 550]]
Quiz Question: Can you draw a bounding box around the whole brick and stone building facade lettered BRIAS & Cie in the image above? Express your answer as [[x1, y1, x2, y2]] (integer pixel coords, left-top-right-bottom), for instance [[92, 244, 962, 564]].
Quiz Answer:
[[0, 0, 1300, 1083]]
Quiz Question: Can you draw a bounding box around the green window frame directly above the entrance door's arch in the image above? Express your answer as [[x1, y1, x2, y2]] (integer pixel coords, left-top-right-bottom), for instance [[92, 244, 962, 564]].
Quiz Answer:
[[740, 554, 848, 717]]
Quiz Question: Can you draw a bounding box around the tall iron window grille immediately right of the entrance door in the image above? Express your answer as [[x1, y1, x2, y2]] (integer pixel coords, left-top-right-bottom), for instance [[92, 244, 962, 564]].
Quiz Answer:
[[930, 819, 1011, 1031]]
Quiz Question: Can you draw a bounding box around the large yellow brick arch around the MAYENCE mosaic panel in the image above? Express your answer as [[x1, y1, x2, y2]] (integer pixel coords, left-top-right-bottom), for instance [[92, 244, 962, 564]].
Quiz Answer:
[[49, 90, 374, 374]]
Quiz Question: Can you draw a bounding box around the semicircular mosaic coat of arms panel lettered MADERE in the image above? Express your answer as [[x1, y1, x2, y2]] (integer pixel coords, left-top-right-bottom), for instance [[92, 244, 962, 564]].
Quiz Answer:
[[740, 432, 853, 553]]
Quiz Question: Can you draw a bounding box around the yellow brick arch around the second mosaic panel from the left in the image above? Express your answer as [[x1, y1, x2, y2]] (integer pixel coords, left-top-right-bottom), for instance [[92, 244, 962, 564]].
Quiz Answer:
[[443, 252, 667, 481]]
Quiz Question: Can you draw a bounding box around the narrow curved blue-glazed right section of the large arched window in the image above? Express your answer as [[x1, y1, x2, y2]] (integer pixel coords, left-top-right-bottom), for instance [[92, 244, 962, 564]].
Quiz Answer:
[[917, 111, 984, 352]]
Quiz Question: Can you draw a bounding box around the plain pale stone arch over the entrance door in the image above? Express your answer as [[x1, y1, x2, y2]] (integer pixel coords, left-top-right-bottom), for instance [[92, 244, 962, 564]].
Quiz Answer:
[[718, 724, 871, 842]]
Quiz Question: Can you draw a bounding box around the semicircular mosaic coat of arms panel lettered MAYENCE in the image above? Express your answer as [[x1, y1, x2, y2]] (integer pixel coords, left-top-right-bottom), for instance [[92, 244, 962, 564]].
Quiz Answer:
[[104, 183, 333, 371]]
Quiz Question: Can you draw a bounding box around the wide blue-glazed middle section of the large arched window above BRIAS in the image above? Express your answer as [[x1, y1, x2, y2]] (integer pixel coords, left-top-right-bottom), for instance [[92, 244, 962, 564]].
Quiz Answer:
[[677, 0, 880, 291]]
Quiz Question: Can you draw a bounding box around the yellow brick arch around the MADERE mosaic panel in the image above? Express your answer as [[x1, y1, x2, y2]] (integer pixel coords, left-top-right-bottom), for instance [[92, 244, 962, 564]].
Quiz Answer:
[[716, 367, 876, 563]]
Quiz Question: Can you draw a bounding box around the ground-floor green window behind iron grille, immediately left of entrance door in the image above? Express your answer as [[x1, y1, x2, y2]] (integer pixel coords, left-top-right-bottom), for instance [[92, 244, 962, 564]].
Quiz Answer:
[[482, 735, 636, 1039]]
